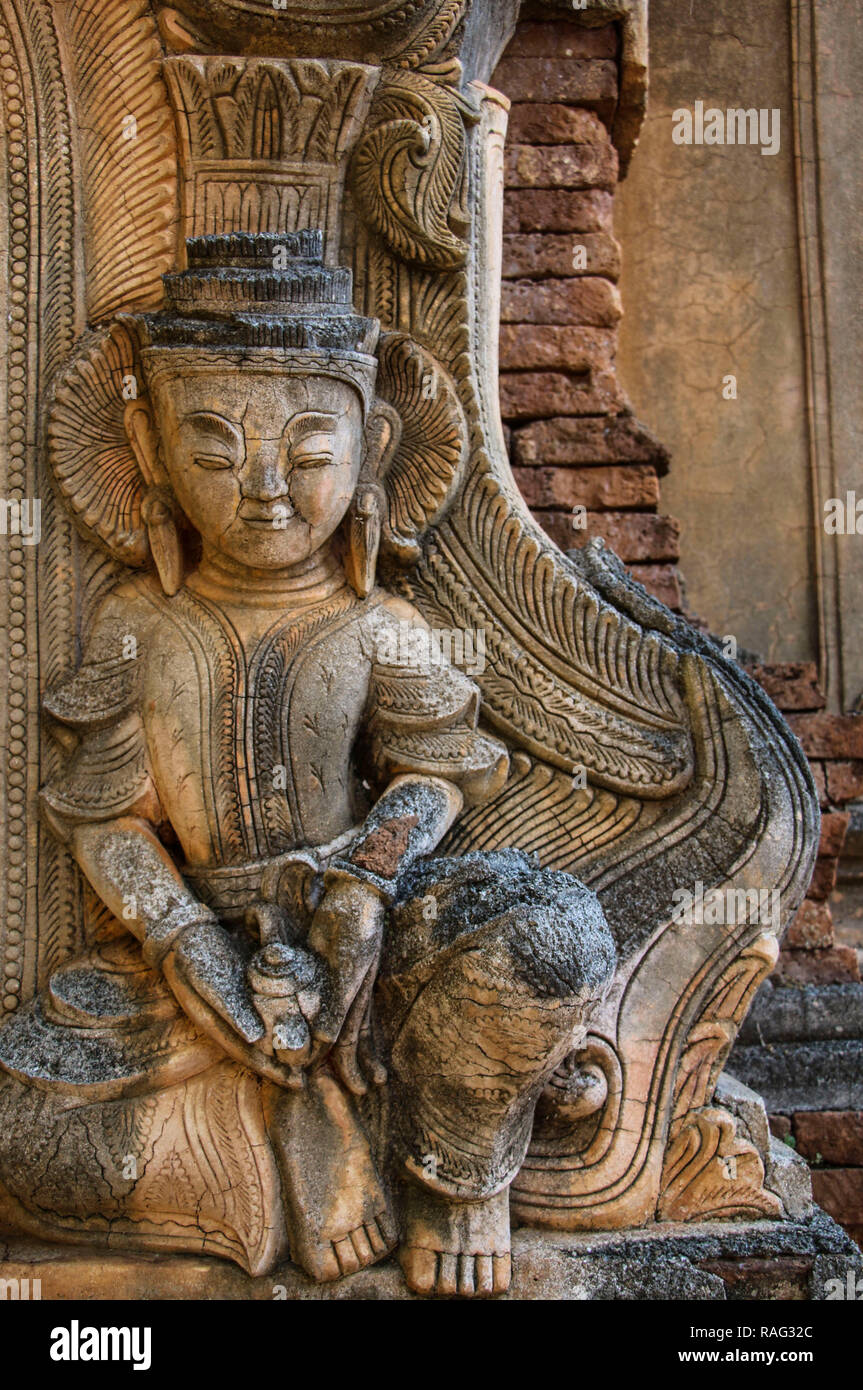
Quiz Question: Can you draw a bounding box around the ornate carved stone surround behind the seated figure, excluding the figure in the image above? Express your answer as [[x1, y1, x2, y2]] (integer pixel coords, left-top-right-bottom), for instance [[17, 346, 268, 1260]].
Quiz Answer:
[[0, 0, 817, 1259]]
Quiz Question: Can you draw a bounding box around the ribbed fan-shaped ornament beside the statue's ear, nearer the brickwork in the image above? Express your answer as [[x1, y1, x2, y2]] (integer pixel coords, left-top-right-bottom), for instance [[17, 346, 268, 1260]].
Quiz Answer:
[[378, 334, 467, 560]]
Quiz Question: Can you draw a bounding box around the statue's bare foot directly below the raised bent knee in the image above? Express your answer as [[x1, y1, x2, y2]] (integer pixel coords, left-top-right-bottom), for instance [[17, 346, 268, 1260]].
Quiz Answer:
[[399, 1183, 513, 1298]]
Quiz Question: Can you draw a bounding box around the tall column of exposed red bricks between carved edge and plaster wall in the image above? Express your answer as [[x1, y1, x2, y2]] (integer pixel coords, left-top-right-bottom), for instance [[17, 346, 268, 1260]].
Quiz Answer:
[[492, 19, 681, 609]]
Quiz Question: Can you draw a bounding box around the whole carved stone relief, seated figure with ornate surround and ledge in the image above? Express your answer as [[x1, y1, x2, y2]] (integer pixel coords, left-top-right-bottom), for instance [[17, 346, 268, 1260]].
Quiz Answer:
[[0, 0, 853, 1298]]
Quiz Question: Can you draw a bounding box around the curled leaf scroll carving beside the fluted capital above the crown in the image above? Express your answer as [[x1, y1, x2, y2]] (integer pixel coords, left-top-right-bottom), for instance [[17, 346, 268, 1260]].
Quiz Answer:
[[353, 68, 468, 270]]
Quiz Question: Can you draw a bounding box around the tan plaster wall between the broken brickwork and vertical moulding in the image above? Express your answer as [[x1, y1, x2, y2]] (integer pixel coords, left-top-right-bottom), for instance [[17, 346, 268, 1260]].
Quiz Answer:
[[616, 0, 817, 662]]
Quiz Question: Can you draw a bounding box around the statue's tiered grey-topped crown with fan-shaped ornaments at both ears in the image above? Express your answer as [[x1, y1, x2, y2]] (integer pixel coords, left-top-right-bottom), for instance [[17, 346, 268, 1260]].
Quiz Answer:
[[49, 231, 467, 591]]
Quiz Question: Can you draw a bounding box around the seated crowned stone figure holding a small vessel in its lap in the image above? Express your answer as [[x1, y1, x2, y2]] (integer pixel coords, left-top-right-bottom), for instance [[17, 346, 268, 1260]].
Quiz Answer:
[[0, 234, 614, 1294]]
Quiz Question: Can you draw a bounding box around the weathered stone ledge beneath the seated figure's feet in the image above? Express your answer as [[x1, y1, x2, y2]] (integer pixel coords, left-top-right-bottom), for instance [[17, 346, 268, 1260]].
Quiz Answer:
[[0, 1212, 863, 1302]]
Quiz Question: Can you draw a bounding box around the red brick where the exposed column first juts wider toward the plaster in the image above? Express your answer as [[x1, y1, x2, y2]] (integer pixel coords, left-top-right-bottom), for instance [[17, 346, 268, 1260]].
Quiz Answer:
[[513, 414, 668, 477]]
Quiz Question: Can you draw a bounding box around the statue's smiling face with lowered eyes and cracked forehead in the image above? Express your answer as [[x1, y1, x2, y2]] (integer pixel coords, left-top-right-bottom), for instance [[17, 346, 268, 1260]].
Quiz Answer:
[[154, 367, 363, 570]]
